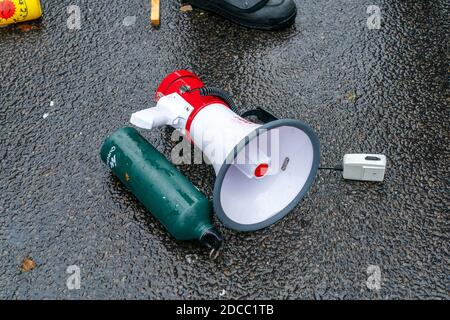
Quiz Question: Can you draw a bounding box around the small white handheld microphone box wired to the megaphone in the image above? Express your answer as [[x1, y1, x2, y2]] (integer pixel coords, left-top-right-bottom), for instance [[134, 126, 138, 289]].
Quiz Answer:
[[343, 153, 386, 181]]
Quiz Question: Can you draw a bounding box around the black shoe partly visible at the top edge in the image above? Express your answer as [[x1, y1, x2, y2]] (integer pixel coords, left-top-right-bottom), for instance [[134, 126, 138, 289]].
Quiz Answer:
[[182, 0, 297, 30]]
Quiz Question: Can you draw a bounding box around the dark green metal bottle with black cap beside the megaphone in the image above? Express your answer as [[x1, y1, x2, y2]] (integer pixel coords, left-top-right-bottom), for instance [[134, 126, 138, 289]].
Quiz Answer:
[[100, 127, 222, 250]]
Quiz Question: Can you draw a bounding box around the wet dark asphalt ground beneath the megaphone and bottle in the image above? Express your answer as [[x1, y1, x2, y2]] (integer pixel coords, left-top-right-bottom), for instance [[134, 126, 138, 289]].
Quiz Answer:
[[0, 0, 450, 299]]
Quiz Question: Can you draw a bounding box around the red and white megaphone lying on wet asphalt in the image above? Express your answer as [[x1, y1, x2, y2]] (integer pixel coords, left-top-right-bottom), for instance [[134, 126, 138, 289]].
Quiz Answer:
[[130, 70, 320, 231]]
